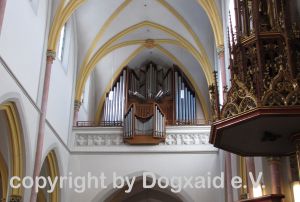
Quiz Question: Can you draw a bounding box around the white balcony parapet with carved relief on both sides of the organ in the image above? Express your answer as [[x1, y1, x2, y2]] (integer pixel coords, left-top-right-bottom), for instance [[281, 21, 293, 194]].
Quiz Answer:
[[70, 126, 217, 152]]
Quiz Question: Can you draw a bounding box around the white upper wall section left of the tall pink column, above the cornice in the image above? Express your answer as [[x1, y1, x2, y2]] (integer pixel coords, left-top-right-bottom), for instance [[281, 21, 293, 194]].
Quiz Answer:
[[0, 0, 47, 101]]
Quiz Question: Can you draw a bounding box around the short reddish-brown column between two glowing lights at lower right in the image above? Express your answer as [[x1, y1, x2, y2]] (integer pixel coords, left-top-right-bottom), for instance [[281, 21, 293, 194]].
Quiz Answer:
[[268, 157, 281, 194]]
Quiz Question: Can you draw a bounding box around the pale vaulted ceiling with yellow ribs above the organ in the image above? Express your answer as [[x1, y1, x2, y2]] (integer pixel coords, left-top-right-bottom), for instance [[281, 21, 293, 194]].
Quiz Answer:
[[68, 0, 220, 120]]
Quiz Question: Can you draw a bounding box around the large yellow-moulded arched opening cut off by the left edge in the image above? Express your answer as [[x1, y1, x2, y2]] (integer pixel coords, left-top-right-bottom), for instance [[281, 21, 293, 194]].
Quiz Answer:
[[0, 102, 25, 201]]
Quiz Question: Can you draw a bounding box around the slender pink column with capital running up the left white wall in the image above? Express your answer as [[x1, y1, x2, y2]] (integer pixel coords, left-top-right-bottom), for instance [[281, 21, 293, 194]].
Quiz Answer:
[[30, 51, 55, 202]]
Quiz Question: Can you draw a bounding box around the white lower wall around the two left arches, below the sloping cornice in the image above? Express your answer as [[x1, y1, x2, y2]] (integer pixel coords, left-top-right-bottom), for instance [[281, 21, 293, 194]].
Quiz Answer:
[[0, 52, 69, 201]]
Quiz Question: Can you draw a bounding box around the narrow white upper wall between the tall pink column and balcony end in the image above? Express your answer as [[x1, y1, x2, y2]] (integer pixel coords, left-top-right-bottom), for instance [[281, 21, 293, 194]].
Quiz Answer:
[[47, 18, 77, 144]]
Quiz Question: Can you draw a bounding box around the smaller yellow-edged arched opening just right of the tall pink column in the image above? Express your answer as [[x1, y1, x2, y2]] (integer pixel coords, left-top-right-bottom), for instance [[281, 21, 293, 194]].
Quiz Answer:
[[37, 150, 60, 202]]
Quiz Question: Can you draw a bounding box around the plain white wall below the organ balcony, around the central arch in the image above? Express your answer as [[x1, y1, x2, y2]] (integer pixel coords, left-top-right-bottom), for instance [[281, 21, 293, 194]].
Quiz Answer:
[[67, 152, 224, 202]]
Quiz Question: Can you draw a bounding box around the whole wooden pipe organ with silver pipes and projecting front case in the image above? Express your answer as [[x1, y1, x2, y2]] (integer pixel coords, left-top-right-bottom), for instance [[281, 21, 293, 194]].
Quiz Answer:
[[103, 62, 196, 145]]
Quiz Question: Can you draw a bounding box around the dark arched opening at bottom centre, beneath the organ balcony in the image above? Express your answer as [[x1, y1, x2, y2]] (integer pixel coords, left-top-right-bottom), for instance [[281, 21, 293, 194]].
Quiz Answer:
[[104, 177, 183, 202]]
